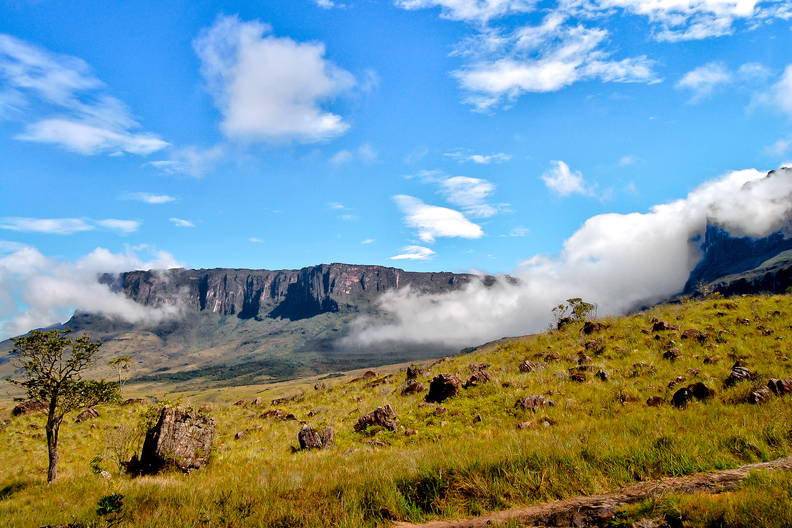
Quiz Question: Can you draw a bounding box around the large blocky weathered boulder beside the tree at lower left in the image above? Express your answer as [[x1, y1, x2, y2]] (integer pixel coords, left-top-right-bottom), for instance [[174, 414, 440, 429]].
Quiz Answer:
[[140, 407, 215, 473]]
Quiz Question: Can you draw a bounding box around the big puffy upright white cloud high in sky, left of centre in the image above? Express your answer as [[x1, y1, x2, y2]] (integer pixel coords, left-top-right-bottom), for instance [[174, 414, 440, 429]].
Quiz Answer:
[[195, 17, 355, 142]]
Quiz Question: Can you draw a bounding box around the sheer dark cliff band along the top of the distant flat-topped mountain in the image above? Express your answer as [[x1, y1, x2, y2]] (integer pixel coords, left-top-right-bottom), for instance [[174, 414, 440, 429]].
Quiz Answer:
[[102, 264, 475, 321]]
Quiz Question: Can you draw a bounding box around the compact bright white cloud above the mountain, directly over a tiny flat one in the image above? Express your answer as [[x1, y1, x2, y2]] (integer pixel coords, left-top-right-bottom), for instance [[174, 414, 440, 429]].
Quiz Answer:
[[393, 194, 484, 244]]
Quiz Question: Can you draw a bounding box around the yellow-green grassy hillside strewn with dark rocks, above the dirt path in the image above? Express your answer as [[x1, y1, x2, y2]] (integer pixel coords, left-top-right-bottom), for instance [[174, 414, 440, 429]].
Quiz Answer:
[[0, 296, 792, 528]]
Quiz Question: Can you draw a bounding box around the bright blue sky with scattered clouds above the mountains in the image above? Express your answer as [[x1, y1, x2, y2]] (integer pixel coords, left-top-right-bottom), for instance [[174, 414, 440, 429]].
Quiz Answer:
[[0, 0, 792, 334]]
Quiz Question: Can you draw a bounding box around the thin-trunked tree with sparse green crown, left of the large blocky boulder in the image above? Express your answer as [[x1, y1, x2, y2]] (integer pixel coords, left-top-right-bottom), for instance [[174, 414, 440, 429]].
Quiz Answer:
[[10, 330, 118, 482]]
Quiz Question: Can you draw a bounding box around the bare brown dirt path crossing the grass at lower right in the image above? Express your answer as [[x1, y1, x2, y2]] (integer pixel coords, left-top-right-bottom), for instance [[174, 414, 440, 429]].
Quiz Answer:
[[392, 457, 792, 528]]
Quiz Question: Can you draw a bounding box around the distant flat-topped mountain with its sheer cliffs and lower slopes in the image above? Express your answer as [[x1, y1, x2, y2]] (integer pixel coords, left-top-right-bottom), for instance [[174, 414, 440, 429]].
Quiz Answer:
[[0, 264, 480, 388]]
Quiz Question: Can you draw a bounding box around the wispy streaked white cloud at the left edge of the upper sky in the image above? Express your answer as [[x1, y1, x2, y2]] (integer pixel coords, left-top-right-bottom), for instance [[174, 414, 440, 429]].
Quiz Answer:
[[0, 34, 168, 155]]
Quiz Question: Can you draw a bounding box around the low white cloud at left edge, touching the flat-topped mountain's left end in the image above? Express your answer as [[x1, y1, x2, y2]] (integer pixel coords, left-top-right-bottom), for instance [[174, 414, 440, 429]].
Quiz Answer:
[[0, 244, 179, 339]]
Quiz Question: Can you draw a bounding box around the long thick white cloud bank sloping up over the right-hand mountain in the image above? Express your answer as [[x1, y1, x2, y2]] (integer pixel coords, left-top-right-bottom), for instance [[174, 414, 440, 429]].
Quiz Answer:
[[349, 165, 792, 346]]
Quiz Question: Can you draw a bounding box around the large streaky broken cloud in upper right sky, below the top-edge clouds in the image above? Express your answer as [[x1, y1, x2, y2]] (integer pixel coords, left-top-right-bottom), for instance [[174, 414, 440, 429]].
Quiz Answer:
[[453, 13, 658, 110]]
